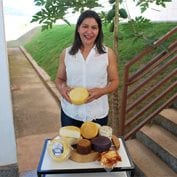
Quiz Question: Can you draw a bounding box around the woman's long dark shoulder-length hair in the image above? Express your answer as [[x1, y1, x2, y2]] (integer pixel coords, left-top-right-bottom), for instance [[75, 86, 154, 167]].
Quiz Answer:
[[69, 10, 105, 55]]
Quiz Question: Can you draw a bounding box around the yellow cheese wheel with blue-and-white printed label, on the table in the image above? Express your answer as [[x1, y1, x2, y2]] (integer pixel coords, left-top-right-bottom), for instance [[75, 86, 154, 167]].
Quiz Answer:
[[48, 139, 71, 162]]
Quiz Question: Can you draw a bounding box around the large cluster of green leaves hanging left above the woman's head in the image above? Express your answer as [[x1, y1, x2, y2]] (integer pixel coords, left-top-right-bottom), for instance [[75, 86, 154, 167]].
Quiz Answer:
[[31, 0, 101, 30]]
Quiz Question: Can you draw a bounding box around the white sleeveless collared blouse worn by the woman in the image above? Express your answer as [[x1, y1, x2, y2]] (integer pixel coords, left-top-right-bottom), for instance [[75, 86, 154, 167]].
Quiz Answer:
[[61, 47, 109, 121]]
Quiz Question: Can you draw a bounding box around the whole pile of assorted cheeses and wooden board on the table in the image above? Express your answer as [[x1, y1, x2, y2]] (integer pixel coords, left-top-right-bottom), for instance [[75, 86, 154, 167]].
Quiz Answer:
[[49, 121, 120, 165]]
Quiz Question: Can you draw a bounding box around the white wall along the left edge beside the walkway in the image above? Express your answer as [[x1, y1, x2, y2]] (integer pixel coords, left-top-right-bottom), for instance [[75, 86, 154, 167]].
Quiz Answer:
[[0, 0, 17, 166]]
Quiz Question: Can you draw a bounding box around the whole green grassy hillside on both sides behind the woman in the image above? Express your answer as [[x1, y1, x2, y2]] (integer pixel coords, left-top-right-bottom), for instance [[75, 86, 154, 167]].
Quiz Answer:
[[24, 23, 176, 80]]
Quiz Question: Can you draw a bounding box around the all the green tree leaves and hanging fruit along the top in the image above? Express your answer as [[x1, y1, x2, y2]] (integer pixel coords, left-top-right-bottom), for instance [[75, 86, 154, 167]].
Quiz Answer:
[[31, 0, 172, 35]]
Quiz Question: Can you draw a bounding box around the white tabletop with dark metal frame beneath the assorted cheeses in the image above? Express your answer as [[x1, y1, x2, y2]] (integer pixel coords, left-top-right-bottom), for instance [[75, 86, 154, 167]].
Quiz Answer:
[[37, 138, 134, 176]]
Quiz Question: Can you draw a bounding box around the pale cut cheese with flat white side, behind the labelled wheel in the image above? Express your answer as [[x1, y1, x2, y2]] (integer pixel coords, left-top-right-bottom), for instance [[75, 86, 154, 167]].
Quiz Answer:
[[59, 126, 81, 139]]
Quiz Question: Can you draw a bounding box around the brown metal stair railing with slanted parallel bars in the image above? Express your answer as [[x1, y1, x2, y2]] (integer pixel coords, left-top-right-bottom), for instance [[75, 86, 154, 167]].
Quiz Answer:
[[119, 27, 177, 139]]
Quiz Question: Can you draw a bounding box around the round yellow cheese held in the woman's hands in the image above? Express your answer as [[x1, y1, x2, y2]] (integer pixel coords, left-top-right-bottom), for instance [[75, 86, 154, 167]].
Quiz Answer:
[[69, 87, 89, 105]]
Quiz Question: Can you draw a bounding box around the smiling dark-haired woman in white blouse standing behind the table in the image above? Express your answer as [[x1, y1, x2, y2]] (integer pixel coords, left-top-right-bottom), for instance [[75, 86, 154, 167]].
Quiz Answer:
[[56, 10, 119, 127]]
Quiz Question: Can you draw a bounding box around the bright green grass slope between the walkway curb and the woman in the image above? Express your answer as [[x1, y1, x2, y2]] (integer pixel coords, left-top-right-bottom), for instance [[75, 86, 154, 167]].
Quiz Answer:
[[24, 25, 74, 80]]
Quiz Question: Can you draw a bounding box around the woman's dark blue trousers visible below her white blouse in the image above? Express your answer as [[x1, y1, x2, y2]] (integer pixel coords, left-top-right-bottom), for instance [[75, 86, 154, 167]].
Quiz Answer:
[[61, 109, 108, 127]]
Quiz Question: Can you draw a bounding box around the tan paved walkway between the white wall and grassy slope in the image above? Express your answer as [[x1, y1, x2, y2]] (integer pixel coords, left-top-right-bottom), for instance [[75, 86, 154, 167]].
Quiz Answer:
[[8, 48, 60, 176]]
